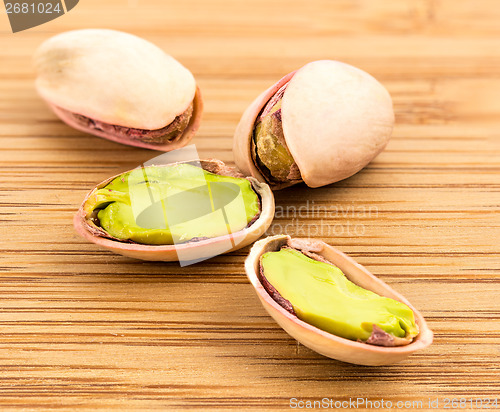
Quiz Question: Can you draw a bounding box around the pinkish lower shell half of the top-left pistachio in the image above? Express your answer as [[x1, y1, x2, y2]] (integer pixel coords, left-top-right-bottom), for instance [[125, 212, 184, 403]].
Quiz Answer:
[[47, 87, 203, 152]]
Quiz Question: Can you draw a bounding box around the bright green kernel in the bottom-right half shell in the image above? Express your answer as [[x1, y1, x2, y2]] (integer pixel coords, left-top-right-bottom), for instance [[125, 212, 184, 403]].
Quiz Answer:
[[261, 248, 418, 341]]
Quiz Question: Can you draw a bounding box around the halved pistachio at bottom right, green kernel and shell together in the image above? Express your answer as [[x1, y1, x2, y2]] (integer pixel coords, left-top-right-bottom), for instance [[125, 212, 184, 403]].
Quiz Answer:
[[245, 235, 433, 365]]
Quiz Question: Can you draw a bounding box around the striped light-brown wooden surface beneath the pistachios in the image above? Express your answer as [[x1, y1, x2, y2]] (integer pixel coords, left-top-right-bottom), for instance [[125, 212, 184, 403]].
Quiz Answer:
[[0, 0, 500, 410]]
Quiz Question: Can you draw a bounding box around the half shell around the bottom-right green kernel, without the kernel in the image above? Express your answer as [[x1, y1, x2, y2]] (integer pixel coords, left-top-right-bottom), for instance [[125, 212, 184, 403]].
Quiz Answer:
[[245, 235, 433, 365]]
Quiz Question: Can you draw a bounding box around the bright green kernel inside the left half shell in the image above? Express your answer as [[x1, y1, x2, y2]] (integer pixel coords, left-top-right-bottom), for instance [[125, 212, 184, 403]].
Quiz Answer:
[[85, 163, 260, 245]]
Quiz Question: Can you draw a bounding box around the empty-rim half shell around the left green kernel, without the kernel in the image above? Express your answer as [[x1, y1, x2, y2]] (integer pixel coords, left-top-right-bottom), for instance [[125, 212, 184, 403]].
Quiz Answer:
[[73, 159, 274, 262]]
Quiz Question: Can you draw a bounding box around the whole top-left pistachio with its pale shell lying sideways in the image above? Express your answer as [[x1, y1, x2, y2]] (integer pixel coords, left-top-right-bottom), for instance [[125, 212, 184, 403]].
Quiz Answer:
[[34, 29, 203, 151]]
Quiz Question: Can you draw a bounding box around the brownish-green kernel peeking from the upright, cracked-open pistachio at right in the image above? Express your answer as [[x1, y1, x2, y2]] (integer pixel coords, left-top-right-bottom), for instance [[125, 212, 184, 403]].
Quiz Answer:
[[254, 99, 298, 182]]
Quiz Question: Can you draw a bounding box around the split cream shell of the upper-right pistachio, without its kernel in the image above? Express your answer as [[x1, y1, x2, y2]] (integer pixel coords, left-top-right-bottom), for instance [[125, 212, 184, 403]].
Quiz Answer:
[[233, 60, 394, 189]]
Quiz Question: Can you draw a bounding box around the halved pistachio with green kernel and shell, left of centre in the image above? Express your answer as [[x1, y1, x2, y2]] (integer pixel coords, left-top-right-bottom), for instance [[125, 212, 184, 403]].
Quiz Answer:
[[74, 160, 274, 261]]
